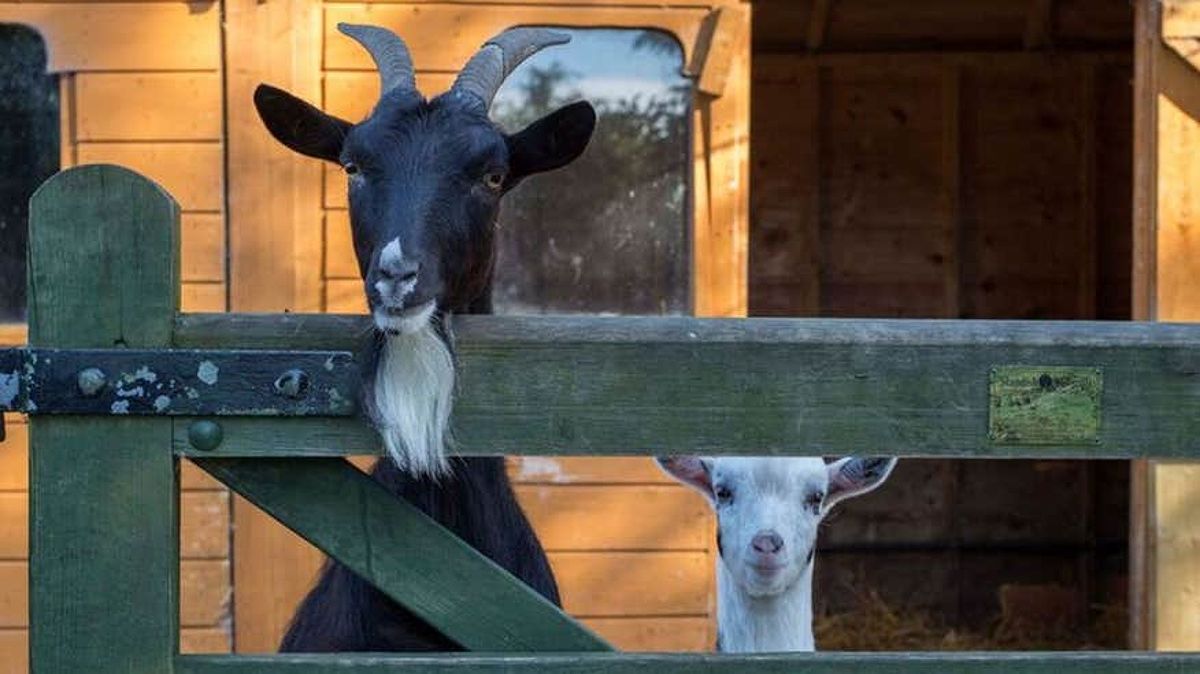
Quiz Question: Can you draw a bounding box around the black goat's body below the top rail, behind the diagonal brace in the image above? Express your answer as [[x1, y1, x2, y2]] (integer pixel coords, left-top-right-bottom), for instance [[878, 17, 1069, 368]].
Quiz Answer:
[[280, 457, 560, 652]]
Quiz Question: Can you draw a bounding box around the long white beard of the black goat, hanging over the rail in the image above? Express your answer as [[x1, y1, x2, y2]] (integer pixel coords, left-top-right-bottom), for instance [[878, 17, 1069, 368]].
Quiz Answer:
[[374, 324, 455, 476]]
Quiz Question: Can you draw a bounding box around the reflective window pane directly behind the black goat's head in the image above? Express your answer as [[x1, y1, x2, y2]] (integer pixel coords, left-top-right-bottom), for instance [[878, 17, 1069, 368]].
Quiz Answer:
[[493, 30, 691, 314]]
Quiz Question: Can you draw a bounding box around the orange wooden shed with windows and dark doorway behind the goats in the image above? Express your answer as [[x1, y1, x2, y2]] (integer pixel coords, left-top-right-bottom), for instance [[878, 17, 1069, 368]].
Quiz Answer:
[[0, 0, 1200, 672]]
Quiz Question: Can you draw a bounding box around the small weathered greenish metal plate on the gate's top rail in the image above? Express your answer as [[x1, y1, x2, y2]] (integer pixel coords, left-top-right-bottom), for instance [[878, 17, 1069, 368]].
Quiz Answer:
[[988, 365, 1104, 445]]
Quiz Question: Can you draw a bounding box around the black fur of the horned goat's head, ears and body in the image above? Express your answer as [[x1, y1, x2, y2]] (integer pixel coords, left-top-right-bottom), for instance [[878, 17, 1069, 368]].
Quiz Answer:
[[254, 43, 596, 652]]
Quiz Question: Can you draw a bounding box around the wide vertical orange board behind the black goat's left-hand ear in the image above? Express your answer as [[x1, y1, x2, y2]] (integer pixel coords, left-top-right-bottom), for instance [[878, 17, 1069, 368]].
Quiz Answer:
[[223, 0, 324, 652]]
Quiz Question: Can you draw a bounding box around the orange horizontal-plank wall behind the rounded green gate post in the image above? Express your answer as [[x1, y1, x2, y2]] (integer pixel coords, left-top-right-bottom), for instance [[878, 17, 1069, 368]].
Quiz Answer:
[[0, 1, 232, 673]]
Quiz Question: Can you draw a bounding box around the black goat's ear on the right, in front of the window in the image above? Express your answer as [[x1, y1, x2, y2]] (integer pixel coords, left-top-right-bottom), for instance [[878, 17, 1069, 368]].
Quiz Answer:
[[504, 101, 596, 189]]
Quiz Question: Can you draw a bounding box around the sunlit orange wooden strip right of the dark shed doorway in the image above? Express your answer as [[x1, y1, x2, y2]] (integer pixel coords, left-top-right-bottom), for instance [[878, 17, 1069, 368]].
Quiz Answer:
[[1130, 0, 1200, 651]]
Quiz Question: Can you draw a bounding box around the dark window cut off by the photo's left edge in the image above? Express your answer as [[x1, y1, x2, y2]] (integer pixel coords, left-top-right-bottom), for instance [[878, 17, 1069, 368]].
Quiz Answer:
[[0, 24, 59, 323]]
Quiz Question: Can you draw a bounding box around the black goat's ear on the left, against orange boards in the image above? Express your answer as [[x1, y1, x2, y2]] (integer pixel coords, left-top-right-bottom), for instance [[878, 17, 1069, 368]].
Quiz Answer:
[[254, 84, 354, 162]]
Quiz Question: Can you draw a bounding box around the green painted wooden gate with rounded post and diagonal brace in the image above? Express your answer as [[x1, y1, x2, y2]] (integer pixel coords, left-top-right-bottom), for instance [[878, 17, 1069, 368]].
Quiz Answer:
[[7, 166, 1200, 674]]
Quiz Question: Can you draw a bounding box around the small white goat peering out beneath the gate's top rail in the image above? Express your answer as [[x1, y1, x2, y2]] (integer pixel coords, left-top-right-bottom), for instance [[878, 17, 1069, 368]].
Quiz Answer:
[[658, 457, 896, 652]]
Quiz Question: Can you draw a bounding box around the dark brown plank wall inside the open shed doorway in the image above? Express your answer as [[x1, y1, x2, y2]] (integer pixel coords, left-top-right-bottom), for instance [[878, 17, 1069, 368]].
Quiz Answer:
[[750, 0, 1133, 628]]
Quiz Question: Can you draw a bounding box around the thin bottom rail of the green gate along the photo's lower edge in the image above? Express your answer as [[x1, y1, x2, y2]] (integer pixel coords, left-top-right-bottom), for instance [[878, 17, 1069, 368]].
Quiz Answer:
[[175, 652, 1200, 674]]
